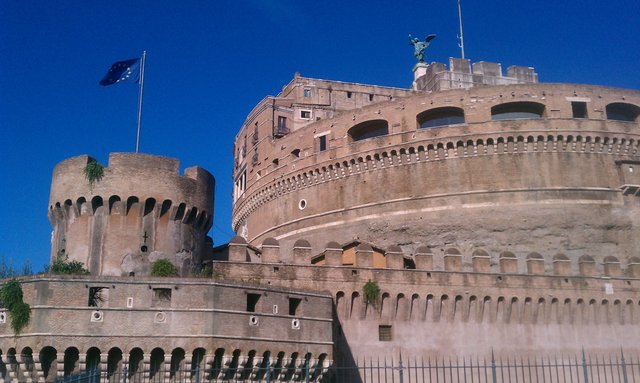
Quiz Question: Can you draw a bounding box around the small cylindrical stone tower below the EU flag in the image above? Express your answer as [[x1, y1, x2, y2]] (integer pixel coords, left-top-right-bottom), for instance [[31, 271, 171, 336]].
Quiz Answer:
[[49, 153, 215, 275]]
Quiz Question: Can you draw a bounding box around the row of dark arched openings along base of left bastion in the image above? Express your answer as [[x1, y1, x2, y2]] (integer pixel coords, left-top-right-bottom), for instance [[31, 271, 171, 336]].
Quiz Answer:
[[5, 346, 327, 382]]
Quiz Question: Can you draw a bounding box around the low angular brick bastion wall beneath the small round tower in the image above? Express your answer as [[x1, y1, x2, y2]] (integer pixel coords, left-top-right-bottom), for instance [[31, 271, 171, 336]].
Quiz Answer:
[[0, 277, 333, 382]]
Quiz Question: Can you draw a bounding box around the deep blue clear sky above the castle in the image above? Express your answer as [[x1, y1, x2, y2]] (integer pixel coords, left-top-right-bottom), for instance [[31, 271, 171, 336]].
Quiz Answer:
[[0, 0, 640, 269]]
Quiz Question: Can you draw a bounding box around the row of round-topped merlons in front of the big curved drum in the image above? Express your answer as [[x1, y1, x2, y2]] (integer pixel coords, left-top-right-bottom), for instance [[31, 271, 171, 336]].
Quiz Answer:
[[215, 237, 640, 281]]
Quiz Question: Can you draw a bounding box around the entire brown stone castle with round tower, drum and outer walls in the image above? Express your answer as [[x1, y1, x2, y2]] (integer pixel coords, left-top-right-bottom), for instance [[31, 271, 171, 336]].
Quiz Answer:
[[0, 55, 640, 382]]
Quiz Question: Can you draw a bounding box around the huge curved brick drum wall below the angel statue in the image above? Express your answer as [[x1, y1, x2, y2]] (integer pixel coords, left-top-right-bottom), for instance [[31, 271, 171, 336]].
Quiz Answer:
[[233, 84, 640, 266]]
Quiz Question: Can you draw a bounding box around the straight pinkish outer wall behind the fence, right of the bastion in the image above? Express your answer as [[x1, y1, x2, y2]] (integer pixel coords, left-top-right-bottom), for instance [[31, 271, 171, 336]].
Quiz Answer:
[[208, 239, 640, 360]]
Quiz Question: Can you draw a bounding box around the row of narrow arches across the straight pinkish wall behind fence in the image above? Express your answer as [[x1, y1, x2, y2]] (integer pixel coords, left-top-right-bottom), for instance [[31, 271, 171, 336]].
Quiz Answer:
[[335, 291, 640, 325]]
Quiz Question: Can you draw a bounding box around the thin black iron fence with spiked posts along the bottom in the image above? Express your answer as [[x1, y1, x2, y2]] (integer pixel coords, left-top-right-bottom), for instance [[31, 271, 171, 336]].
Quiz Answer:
[[48, 350, 640, 383]]
